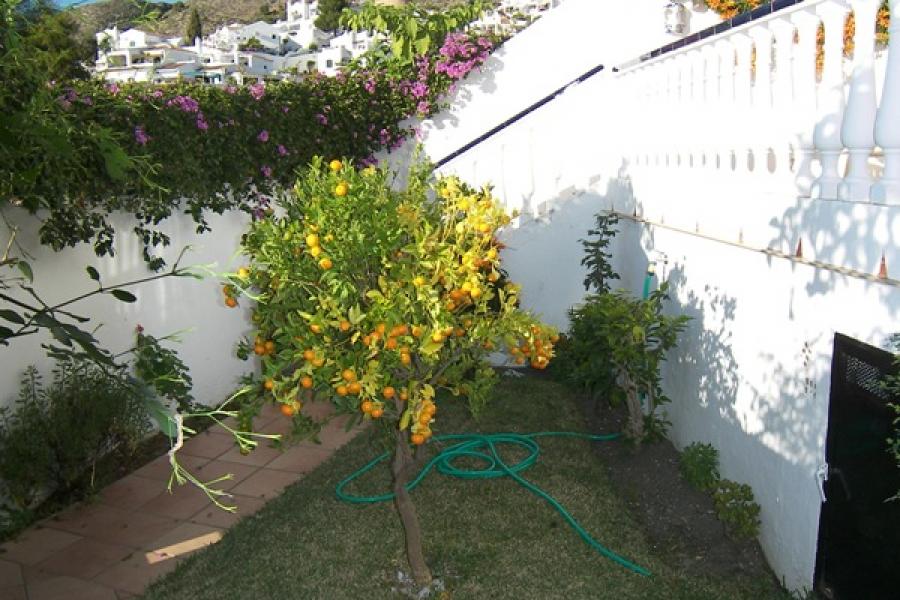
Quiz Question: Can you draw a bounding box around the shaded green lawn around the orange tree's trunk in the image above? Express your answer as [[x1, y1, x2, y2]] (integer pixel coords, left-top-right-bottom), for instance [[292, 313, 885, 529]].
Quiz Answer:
[[145, 378, 789, 600]]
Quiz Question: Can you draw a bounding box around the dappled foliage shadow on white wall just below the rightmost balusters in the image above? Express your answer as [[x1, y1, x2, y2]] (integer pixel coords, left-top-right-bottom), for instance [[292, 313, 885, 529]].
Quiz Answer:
[[769, 198, 900, 318]]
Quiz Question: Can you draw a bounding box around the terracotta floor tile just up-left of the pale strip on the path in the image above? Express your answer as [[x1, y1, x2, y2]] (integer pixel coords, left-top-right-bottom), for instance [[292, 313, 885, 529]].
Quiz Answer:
[[47, 504, 175, 548]]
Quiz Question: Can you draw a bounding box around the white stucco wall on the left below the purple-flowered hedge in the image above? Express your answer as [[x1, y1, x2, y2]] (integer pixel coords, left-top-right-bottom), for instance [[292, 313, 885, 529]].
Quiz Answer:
[[0, 210, 251, 406]]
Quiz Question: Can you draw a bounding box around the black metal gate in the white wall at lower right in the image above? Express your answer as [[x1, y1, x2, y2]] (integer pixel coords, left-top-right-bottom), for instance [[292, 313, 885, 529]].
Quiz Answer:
[[815, 334, 900, 600]]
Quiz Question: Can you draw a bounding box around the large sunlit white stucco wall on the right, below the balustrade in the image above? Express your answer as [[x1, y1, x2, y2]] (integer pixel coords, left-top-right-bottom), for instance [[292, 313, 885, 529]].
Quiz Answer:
[[402, 0, 900, 589]]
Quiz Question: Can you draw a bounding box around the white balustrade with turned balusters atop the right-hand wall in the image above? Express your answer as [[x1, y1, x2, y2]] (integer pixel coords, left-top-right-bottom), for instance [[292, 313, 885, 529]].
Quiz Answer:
[[613, 0, 900, 204]]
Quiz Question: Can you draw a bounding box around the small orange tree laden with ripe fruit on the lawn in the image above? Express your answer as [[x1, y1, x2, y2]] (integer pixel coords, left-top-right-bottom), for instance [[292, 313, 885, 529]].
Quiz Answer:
[[227, 158, 556, 583]]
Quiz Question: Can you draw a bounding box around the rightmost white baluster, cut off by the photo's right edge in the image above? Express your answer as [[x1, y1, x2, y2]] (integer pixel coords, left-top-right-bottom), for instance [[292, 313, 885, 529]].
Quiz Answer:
[[871, 0, 900, 204]]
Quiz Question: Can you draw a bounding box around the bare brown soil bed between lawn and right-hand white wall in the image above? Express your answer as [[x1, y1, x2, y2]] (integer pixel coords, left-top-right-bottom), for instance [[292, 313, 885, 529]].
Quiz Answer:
[[583, 400, 774, 578]]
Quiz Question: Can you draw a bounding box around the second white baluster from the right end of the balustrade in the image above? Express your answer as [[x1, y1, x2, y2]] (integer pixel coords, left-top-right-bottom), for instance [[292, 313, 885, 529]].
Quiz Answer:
[[838, 0, 881, 202]]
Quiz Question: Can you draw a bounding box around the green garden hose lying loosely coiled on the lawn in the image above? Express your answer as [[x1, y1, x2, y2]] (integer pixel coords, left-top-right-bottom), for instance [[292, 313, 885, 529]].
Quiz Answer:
[[335, 431, 650, 576]]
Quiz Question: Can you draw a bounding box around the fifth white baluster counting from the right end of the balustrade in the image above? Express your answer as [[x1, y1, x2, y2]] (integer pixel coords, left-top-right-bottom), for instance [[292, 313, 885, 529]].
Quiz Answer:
[[770, 17, 796, 175]]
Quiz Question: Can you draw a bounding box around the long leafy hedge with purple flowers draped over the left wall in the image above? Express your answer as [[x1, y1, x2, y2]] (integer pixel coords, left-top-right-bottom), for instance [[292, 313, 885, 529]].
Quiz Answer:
[[0, 0, 493, 268]]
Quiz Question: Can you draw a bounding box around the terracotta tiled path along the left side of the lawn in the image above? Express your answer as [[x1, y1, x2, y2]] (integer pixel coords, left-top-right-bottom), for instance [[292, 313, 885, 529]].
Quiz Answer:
[[0, 403, 360, 600]]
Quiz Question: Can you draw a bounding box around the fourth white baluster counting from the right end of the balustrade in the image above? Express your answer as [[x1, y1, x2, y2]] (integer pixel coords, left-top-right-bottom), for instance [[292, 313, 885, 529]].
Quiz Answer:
[[791, 11, 819, 197]]
